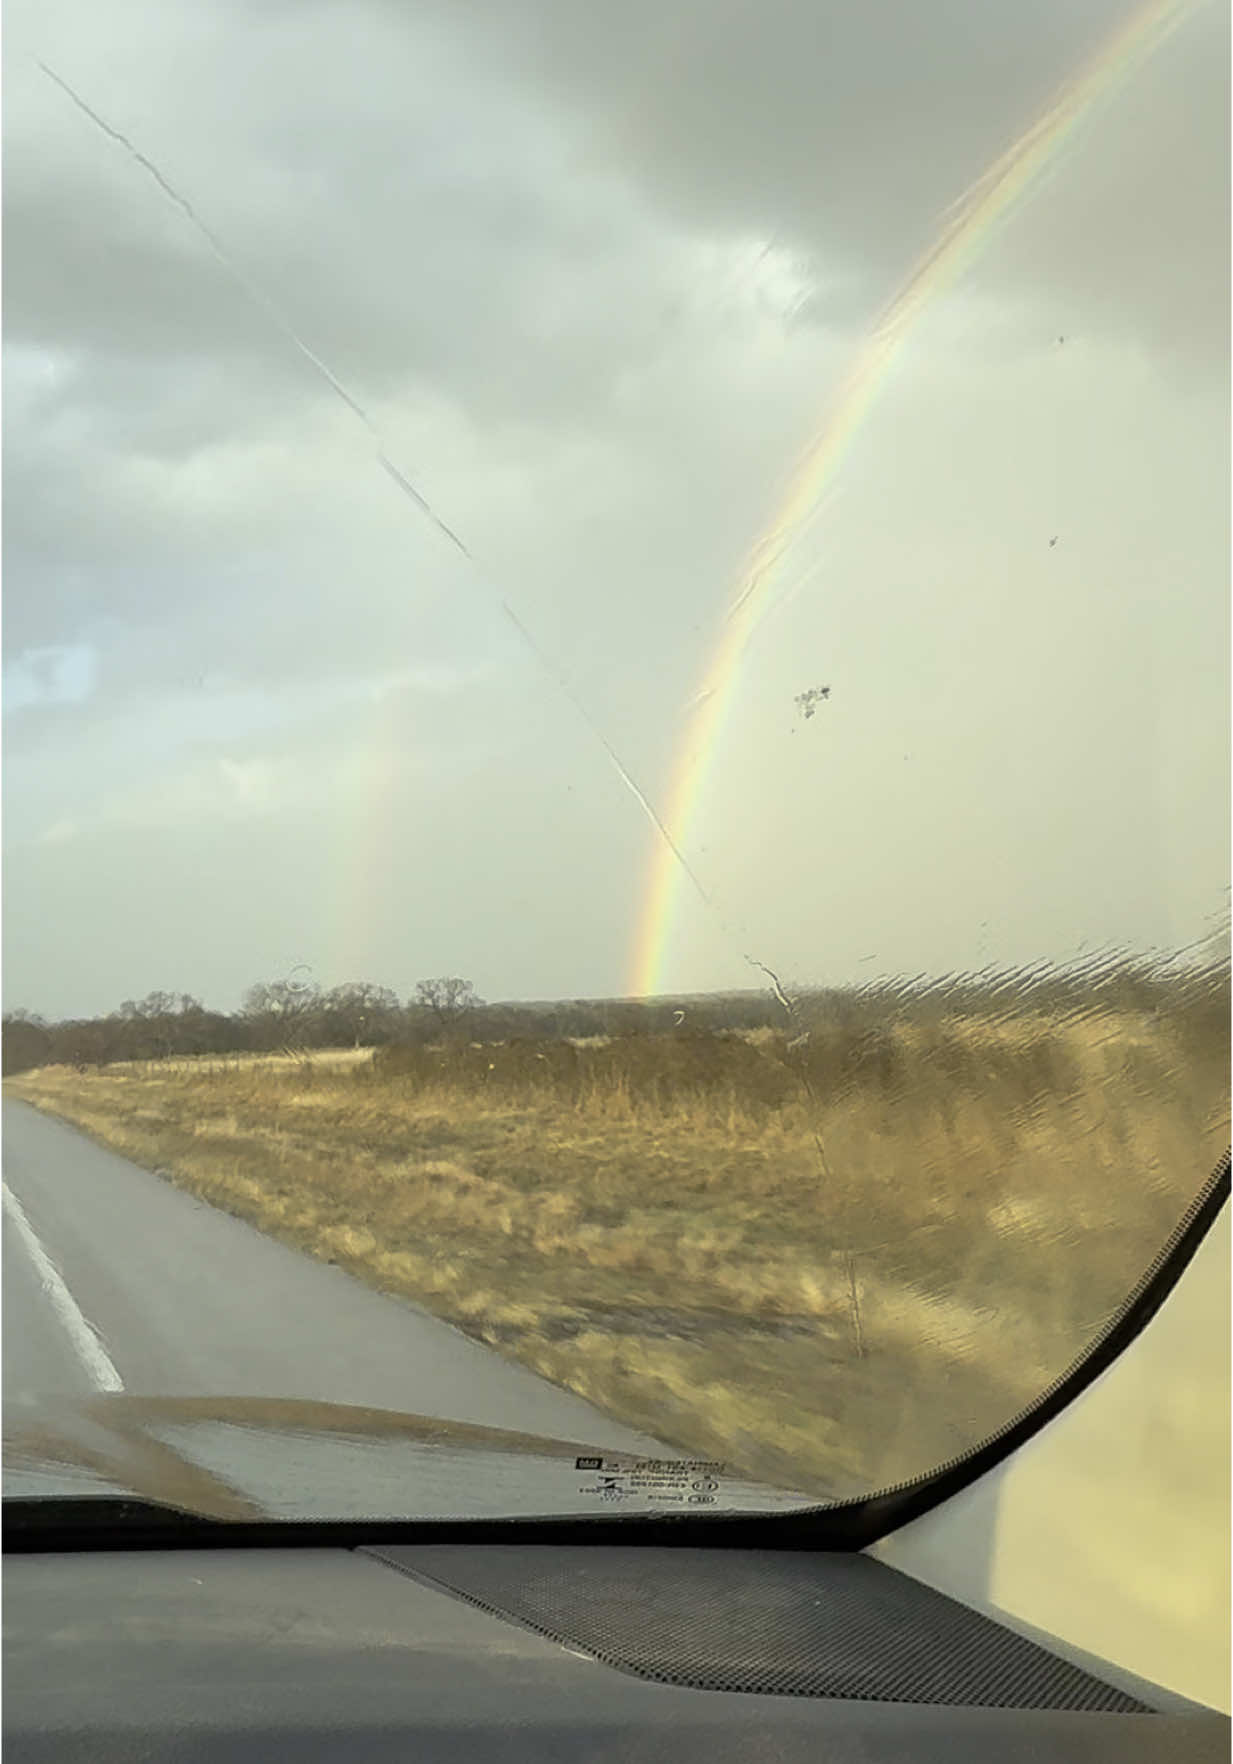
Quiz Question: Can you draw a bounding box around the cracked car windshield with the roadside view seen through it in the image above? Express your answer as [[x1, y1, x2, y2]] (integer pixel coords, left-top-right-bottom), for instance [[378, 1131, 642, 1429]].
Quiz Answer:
[[4, 0, 1229, 1517]]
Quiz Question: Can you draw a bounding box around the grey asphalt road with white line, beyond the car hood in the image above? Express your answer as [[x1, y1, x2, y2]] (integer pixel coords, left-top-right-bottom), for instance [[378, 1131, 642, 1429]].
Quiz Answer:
[[4, 1101, 663, 1452]]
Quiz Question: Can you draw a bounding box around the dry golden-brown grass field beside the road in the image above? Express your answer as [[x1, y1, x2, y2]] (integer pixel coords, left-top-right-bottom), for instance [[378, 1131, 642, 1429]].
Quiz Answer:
[[5, 990, 1229, 1494]]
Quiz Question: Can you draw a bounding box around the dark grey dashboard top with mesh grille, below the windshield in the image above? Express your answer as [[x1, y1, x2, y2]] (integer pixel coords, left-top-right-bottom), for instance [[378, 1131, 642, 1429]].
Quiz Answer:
[[4, 1542, 1229, 1764]]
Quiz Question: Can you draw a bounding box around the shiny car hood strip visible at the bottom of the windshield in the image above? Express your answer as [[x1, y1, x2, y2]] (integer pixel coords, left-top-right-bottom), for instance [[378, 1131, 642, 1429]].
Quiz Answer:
[[4, 1394, 818, 1522]]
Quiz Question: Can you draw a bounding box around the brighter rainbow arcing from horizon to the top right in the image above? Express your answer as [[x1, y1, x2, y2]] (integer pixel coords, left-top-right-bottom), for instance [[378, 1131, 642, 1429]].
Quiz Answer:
[[628, 0, 1198, 997]]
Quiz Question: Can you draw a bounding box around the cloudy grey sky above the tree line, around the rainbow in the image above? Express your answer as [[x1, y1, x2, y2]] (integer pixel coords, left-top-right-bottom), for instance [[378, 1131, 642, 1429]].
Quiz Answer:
[[4, 0, 1229, 1016]]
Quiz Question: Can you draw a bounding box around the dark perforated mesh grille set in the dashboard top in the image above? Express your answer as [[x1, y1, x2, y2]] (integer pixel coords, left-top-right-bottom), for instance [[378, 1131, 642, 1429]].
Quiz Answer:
[[365, 1544, 1150, 1713]]
